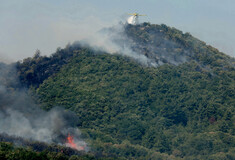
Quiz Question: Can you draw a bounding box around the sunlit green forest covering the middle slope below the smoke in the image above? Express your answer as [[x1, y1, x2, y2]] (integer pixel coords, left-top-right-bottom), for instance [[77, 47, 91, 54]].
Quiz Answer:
[[37, 52, 234, 158]]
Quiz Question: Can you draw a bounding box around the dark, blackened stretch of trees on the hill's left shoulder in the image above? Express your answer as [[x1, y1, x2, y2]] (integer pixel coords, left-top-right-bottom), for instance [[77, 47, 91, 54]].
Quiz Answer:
[[16, 44, 80, 87]]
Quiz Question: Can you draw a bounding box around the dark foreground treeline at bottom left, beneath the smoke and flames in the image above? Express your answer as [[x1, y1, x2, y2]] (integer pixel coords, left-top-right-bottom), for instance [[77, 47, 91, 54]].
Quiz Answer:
[[0, 134, 118, 160]]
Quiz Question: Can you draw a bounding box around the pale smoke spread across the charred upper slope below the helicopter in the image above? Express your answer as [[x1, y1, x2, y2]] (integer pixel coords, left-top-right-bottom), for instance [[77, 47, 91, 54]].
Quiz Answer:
[[74, 16, 193, 67]]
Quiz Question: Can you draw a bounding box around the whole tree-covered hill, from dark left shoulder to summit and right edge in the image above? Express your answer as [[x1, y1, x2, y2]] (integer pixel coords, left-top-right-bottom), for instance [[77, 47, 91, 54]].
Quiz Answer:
[[10, 23, 235, 159]]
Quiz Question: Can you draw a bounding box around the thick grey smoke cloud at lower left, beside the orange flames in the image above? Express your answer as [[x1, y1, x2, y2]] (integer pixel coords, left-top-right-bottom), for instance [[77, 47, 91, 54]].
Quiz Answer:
[[0, 64, 88, 150]]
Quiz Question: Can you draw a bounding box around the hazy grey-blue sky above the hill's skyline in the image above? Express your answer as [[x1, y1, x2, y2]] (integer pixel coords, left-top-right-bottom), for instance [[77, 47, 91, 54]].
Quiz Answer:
[[0, 0, 235, 61]]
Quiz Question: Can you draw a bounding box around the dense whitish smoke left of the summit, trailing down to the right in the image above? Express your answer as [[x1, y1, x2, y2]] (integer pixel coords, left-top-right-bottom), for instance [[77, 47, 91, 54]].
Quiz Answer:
[[79, 19, 157, 67]]
